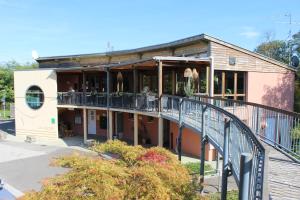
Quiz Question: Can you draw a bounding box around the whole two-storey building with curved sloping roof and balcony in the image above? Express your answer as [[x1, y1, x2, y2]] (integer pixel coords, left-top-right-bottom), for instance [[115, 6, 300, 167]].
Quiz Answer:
[[14, 34, 295, 160]]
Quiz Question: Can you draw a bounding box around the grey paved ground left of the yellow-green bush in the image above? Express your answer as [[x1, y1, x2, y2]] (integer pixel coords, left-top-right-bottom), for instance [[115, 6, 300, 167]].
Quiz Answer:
[[0, 141, 92, 197]]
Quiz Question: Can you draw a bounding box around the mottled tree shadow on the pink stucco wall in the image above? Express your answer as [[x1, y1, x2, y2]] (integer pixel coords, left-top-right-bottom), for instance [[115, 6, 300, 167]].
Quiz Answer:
[[262, 73, 295, 111]]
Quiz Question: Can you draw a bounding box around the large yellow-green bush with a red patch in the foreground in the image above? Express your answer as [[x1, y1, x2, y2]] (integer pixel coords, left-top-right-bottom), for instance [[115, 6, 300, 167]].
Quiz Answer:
[[22, 141, 200, 200]]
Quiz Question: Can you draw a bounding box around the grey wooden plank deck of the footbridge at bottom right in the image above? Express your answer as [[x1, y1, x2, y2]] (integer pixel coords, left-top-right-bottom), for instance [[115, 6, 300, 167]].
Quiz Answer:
[[268, 147, 300, 200]]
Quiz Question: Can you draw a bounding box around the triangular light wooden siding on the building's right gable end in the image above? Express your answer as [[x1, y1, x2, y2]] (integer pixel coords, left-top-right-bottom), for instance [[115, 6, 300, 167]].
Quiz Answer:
[[210, 42, 289, 73]]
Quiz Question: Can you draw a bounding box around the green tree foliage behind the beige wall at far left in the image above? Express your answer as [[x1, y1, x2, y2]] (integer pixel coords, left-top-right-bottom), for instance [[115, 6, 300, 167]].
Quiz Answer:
[[0, 61, 37, 102]]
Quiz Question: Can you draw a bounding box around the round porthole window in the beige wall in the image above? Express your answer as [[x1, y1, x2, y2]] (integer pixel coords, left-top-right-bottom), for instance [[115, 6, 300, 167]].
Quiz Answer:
[[26, 85, 44, 110]]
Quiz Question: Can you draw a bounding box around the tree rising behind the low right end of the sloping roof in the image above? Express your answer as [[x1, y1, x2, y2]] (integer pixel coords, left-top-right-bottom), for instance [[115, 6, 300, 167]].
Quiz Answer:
[[254, 40, 289, 63]]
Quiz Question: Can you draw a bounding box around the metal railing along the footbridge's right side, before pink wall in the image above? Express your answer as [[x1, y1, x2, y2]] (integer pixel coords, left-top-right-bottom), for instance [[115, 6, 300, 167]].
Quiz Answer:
[[193, 96, 300, 162]]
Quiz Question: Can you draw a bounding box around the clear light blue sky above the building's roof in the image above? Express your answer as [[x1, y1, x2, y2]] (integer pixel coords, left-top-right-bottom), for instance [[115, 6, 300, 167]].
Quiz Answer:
[[0, 0, 300, 63]]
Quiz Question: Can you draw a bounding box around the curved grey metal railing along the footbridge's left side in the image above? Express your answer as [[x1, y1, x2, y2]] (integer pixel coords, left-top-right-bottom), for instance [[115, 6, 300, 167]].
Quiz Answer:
[[161, 95, 267, 199]]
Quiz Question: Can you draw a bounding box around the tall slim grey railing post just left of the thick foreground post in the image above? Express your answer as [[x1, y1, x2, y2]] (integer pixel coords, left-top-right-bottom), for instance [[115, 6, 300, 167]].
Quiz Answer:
[[221, 118, 230, 200]]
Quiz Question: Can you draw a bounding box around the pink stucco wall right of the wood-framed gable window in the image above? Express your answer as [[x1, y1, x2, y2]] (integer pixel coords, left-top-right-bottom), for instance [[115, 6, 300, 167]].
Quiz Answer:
[[247, 72, 295, 111]]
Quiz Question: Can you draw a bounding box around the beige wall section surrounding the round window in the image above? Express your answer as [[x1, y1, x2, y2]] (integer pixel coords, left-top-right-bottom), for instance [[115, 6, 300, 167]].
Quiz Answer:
[[14, 70, 58, 139]]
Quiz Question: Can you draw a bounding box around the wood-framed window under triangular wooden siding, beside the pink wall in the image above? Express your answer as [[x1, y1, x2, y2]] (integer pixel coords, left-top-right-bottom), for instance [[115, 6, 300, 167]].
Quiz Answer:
[[214, 71, 246, 101]]
